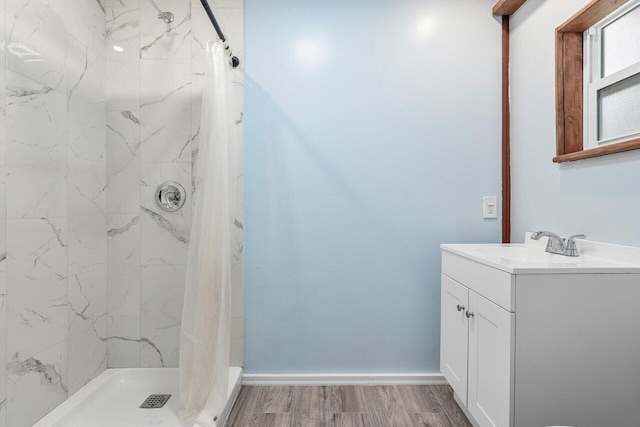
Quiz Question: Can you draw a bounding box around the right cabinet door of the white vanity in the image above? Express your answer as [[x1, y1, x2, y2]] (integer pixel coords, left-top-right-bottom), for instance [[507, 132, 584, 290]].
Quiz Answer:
[[467, 291, 515, 427]]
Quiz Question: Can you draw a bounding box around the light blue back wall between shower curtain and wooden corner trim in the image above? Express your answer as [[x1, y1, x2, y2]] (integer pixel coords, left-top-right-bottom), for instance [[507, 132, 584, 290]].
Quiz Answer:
[[244, 0, 501, 373]]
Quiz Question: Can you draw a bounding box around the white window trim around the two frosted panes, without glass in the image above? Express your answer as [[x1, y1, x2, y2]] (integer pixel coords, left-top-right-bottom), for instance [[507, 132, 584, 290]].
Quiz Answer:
[[583, 0, 640, 150]]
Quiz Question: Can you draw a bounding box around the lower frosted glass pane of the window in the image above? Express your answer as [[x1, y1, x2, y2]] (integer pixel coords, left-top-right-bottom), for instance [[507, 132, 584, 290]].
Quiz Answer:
[[598, 74, 640, 141]]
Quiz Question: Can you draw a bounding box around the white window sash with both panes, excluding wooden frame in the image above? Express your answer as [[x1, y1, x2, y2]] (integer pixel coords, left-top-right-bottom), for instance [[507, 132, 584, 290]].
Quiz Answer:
[[583, 0, 640, 150]]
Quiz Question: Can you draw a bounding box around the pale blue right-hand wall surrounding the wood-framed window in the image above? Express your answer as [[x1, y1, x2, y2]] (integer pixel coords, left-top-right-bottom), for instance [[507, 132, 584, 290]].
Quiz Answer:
[[511, 0, 640, 245]]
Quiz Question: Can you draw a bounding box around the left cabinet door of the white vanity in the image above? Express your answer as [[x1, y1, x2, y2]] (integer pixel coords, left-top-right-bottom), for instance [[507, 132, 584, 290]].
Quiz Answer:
[[440, 274, 469, 405]]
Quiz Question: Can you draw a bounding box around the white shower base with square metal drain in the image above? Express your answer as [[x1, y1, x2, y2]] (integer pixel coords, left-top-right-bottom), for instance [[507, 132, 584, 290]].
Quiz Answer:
[[34, 368, 242, 427]]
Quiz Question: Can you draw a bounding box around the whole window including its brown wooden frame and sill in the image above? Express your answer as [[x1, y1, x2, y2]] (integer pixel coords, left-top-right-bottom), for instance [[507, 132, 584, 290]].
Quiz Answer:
[[553, 0, 640, 163]]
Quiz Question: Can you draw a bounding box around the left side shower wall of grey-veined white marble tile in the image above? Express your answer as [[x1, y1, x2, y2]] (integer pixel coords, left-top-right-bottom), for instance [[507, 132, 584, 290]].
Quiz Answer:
[[0, 0, 107, 427]]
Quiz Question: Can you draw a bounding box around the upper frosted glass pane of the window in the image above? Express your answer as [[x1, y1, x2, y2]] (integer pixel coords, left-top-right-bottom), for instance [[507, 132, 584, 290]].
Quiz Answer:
[[602, 7, 640, 77]]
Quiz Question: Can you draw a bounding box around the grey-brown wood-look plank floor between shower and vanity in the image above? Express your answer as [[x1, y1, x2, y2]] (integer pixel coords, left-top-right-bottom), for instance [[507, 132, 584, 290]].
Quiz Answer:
[[227, 386, 471, 427]]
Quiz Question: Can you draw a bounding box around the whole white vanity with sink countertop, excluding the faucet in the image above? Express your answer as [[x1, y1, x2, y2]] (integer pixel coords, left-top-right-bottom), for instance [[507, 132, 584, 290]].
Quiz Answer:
[[440, 239, 640, 427]]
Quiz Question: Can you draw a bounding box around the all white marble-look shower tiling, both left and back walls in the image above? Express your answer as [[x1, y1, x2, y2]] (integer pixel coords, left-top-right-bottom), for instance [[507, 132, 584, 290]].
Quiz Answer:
[[0, 0, 242, 427]]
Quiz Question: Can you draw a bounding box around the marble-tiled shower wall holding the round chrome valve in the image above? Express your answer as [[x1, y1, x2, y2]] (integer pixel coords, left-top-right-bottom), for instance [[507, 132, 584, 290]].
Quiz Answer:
[[106, 0, 243, 367]]
